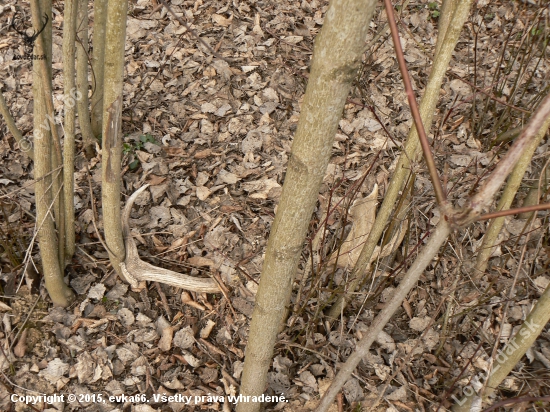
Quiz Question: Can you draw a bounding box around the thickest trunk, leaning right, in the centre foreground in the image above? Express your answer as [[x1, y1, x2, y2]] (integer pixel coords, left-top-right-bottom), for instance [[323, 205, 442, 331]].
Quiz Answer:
[[237, 0, 376, 412]]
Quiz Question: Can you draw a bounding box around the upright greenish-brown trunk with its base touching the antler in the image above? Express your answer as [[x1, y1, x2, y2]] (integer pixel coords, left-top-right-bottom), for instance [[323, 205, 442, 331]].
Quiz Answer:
[[102, 0, 128, 277]]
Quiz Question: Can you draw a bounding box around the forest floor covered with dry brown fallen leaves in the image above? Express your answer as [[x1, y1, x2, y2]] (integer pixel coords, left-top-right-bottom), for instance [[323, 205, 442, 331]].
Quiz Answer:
[[0, 0, 550, 412]]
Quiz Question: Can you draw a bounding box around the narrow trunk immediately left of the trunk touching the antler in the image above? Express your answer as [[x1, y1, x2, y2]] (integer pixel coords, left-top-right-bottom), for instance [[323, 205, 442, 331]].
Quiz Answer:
[[90, 0, 106, 138]]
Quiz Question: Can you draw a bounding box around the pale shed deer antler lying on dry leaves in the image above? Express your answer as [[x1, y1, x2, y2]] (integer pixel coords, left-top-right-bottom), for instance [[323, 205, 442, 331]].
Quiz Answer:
[[120, 185, 221, 293]]
